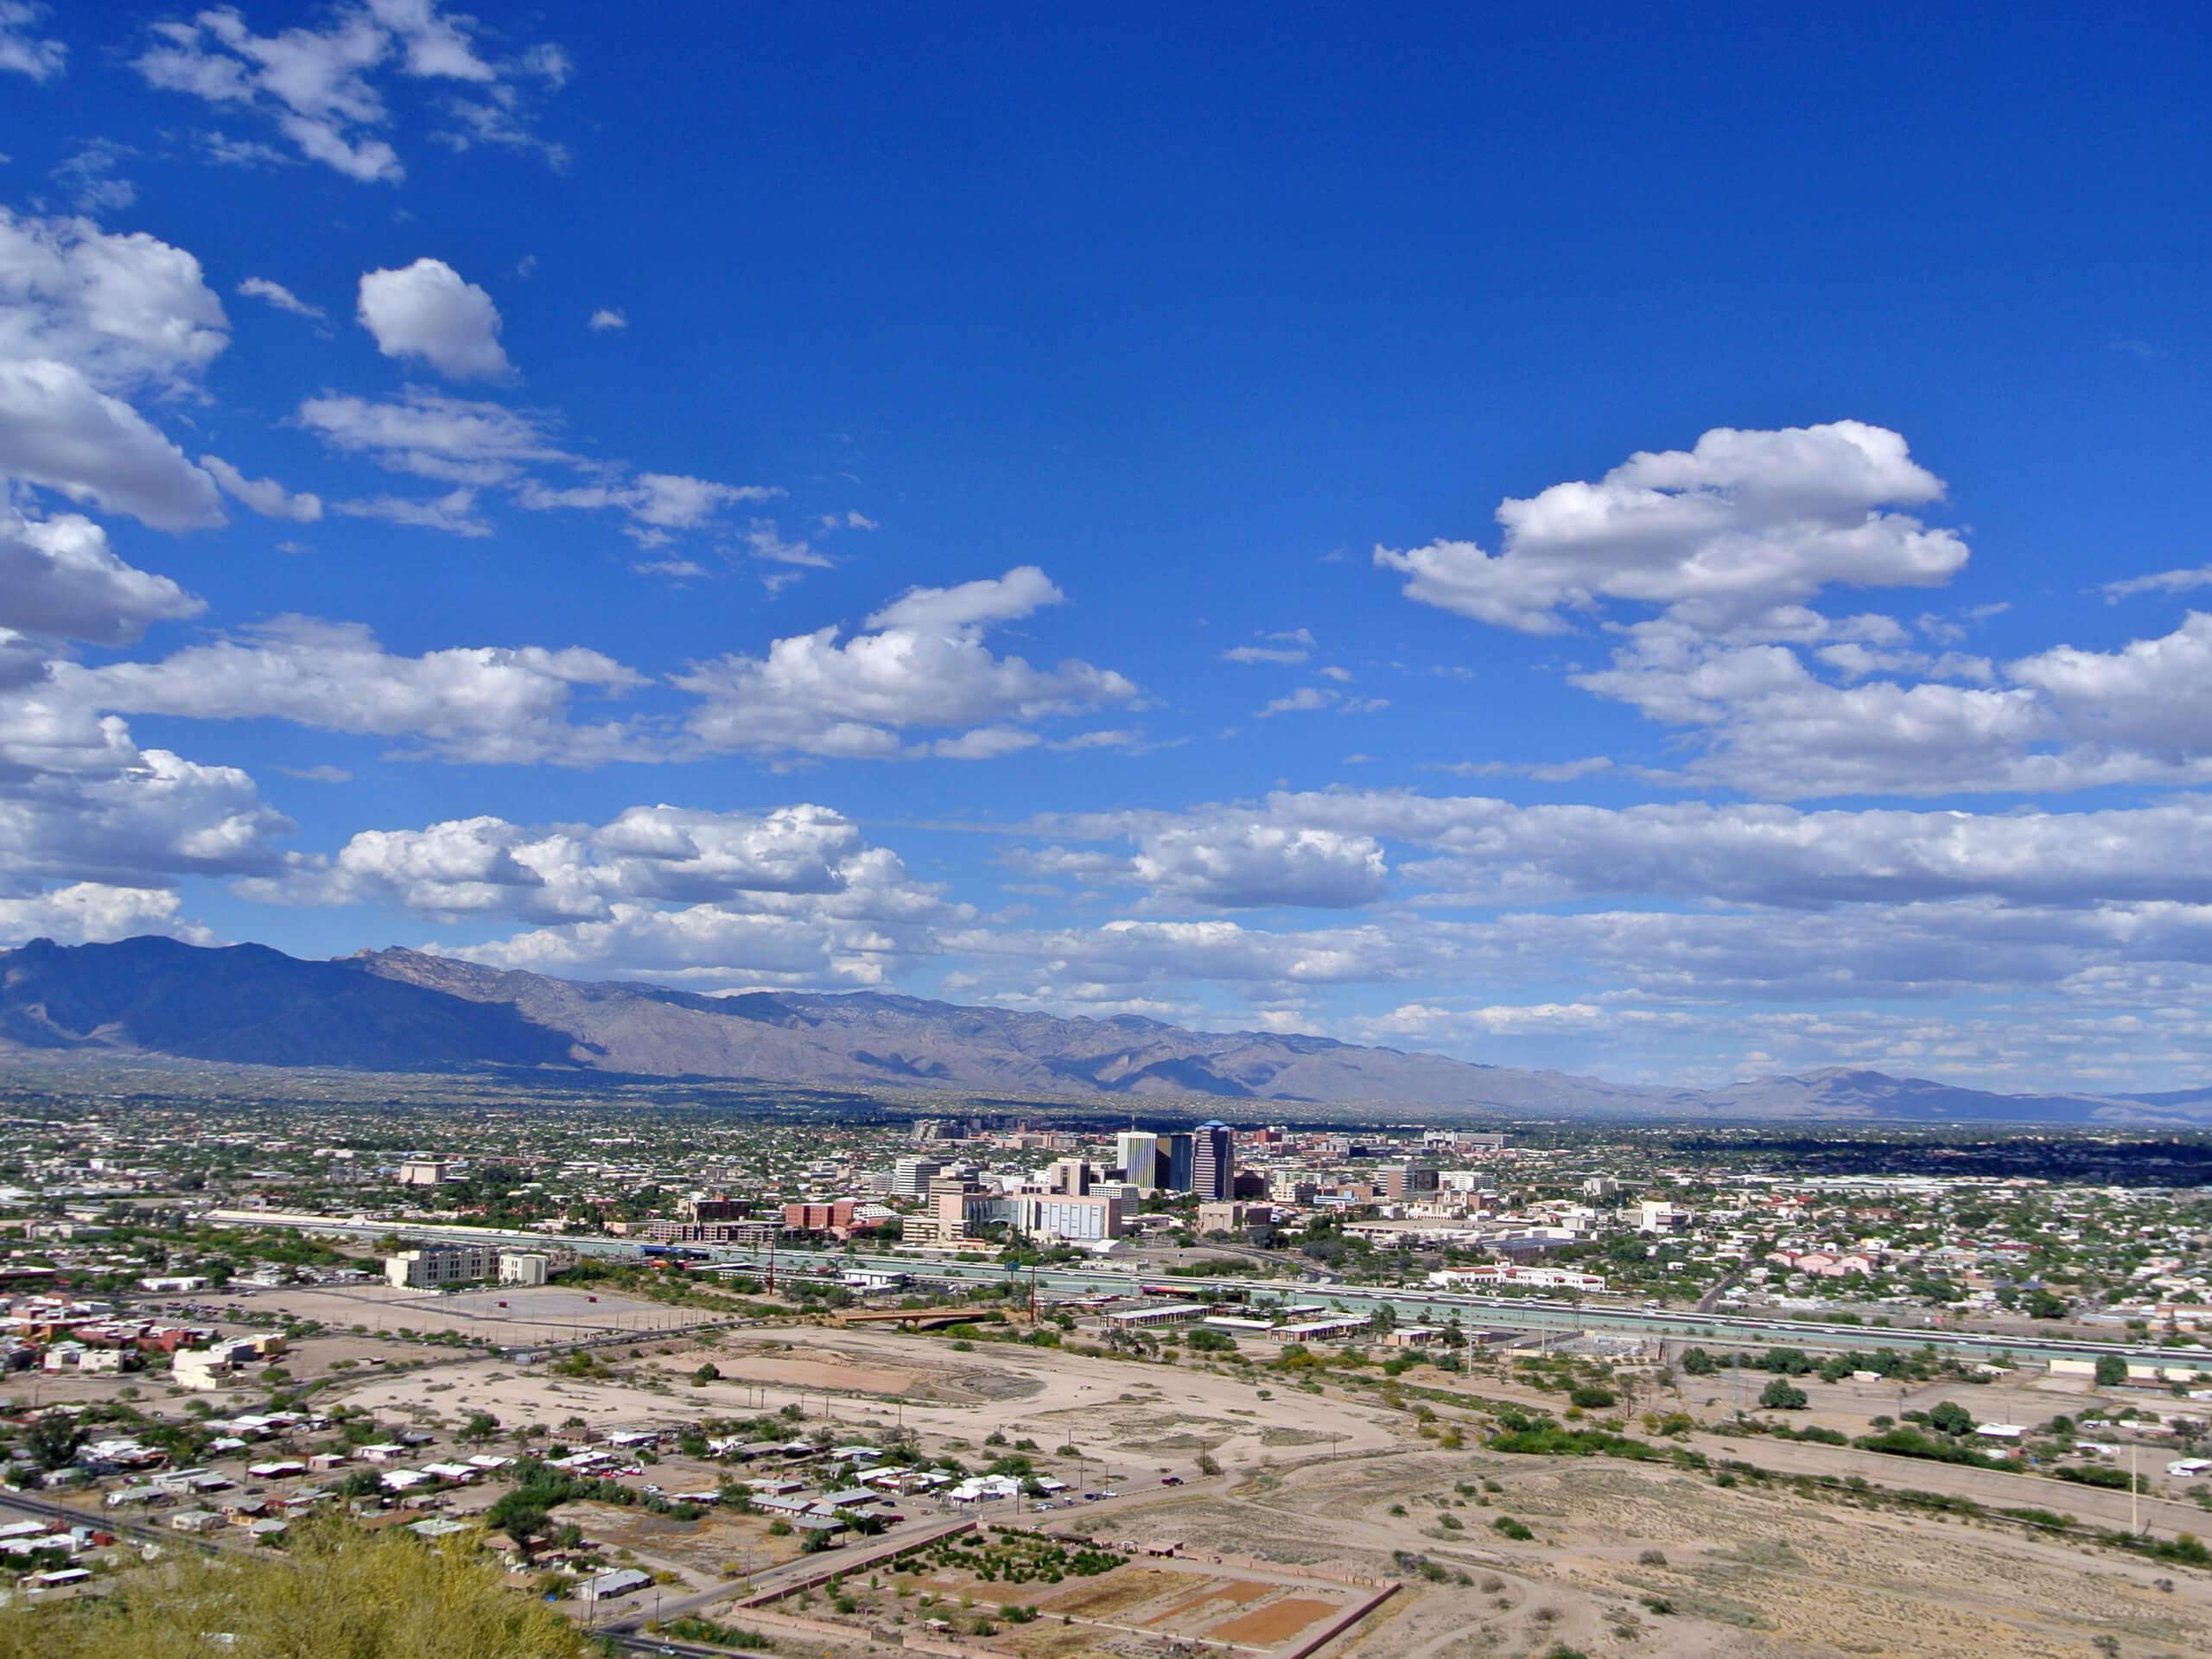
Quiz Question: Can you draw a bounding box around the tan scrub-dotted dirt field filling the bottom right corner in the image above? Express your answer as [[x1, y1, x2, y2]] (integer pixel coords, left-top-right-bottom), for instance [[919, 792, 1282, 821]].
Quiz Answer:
[[1117, 1451, 2212, 1659]]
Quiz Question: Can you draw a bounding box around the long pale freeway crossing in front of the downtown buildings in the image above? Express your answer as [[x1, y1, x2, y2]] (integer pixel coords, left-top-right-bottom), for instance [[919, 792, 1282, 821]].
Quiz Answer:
[[206, 1210, 2212, 1382]]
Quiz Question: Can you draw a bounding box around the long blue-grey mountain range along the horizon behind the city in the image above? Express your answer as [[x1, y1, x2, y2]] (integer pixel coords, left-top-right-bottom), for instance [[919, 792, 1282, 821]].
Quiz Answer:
[[0, 936, 2185, 1123]]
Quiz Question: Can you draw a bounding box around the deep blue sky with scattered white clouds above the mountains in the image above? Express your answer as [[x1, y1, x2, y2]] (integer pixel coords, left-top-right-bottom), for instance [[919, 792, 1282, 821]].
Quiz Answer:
[[0, 0, 2212, 1090]]
